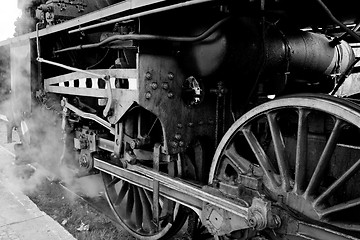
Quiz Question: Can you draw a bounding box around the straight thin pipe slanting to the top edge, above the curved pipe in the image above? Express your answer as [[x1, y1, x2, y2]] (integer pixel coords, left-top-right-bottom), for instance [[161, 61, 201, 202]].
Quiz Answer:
[[69, 0, 218, 34]]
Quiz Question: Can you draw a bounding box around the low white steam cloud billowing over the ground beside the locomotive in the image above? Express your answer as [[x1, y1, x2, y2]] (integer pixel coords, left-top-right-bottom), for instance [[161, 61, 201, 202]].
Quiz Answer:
[[1, 95, 103, 197]]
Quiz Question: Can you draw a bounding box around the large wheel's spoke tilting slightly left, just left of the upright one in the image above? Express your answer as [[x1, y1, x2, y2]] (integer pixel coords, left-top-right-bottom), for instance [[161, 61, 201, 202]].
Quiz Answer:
[[267, 113, 290, 191]]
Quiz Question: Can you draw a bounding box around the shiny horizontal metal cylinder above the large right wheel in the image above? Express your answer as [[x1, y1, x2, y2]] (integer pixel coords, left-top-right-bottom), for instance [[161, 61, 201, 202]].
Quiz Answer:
[[266, 31, 355, 75]]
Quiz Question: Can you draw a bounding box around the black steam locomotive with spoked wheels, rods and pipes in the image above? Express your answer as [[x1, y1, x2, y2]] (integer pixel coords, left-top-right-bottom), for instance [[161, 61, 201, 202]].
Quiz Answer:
[[0, 0, 360, 240]]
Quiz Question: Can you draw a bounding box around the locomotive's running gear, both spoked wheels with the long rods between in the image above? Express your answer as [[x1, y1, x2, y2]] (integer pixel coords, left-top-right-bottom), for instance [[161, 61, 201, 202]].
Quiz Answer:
[[57, 91, 360, 239]]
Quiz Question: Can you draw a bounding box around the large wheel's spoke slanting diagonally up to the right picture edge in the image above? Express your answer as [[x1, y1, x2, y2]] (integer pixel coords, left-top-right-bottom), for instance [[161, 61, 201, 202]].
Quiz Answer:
[[314, 159, 360, 205]]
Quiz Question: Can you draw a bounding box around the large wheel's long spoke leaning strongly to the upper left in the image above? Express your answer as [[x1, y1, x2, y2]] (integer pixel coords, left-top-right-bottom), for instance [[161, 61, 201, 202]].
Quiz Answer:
[[242, 127, 278, 187]]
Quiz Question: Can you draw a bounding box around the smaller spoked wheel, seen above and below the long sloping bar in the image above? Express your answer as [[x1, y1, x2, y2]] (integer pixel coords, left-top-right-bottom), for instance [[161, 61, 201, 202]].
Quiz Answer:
[[101, 109, 187, 240]]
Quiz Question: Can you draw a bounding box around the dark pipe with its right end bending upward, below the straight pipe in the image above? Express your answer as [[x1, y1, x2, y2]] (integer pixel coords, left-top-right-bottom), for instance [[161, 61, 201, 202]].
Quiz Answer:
[[54, 17, 230, 53]]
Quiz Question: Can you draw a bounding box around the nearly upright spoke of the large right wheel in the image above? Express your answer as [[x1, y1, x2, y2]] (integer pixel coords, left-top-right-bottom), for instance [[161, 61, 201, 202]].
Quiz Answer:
[[294, 109, 308, 194]]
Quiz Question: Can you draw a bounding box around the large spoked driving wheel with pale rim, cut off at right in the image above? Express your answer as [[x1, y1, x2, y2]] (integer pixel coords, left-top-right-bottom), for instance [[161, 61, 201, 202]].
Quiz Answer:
[[209, 95, 360, 239]]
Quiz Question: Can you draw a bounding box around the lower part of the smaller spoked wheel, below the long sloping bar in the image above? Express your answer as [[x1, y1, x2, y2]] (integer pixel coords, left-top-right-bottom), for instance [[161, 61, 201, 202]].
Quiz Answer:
[[101, 172, 186, 239]]
